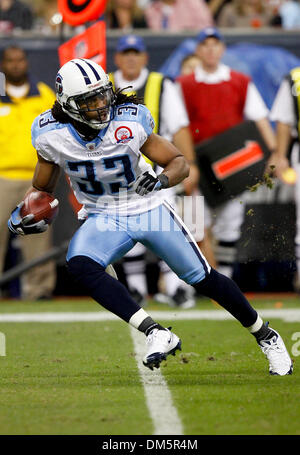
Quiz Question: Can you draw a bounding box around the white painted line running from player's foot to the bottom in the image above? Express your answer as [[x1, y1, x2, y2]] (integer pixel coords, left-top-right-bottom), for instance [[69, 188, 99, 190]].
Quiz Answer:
[[130, 327, 183, 435]]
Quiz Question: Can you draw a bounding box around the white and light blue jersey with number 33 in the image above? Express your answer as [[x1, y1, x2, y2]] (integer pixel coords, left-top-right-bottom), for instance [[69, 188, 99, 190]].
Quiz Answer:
[[32, 104, 161, 215]]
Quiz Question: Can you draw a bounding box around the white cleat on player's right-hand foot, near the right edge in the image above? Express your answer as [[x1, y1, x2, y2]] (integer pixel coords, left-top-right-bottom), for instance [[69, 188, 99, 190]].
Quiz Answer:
[[258, 327, 293, 376]]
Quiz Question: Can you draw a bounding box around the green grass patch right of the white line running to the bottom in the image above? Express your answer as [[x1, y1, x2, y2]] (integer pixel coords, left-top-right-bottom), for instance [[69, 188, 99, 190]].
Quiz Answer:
[[164, 320, 300, 435]]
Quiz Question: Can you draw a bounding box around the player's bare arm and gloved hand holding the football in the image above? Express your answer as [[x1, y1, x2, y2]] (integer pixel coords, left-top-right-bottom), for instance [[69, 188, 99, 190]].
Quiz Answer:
[[8, 156, 59, 235]]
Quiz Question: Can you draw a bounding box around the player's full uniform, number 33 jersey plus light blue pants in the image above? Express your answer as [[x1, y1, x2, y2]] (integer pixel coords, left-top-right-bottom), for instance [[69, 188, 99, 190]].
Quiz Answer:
[[32, 104, 210, 284]]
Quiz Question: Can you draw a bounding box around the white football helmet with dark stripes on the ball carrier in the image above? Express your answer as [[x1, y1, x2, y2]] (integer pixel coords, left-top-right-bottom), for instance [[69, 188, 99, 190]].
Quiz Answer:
[[55, 58, 115, 130]]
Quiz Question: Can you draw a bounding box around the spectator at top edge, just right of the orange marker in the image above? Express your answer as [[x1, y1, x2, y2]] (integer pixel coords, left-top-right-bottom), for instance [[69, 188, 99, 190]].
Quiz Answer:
[[105, 0, 147, 30]]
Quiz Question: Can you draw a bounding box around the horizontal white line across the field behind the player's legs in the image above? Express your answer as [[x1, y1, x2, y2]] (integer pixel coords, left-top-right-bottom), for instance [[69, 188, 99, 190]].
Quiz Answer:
[[0, 305, 300, 323]]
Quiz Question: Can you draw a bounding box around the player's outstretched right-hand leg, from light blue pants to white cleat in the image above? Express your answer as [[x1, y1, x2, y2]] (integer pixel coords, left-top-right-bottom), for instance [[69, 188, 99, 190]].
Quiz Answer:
[[145, 203, 292, 375]]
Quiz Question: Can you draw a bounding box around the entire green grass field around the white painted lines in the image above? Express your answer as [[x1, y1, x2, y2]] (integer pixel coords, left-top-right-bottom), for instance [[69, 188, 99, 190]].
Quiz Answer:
[[0, 296, 300, 435]]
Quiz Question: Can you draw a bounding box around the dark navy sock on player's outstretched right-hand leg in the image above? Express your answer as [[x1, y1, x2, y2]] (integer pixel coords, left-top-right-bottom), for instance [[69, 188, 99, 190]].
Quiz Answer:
[[193, 269, 258, 327]]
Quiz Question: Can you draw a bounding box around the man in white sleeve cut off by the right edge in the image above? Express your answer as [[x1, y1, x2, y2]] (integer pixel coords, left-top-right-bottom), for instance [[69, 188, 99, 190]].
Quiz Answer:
[[270, 67, 300, 292]]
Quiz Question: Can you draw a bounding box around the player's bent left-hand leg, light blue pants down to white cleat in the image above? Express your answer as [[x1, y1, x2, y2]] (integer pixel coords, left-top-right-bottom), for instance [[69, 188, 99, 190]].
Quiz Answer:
[[67, 215, 181, 369]]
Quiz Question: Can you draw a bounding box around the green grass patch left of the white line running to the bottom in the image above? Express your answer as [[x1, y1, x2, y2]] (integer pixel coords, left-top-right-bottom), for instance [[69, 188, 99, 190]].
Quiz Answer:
[[0, 322, 152, 434]]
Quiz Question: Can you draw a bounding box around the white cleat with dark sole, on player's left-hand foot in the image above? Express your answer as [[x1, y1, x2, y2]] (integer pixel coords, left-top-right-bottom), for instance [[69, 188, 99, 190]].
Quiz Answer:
[[143, 327, 181, 370]]
